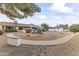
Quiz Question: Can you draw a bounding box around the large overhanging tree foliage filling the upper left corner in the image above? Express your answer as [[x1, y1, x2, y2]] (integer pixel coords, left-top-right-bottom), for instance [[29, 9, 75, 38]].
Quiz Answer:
[[0, 3, 41, 20]]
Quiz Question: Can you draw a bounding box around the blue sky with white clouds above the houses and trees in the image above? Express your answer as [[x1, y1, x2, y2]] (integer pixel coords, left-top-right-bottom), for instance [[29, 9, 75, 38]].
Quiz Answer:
[[0, 3, 79, 26]]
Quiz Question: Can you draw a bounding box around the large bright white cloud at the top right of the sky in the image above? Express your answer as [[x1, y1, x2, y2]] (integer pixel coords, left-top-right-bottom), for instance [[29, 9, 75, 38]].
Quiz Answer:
[[50, 3, 73, 13]]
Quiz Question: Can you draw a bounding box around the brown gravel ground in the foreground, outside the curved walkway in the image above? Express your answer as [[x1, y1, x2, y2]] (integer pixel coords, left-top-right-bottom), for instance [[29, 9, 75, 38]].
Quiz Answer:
[[0, 32, 79, 56]]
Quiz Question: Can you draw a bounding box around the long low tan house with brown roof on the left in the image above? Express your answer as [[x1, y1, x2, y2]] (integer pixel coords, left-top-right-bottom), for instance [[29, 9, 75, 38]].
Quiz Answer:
[[0, 22, 38, 31]]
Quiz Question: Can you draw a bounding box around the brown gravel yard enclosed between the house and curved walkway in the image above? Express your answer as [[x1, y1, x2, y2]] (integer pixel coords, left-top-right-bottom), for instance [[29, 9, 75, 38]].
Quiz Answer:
[[15, 32, 70, 40]]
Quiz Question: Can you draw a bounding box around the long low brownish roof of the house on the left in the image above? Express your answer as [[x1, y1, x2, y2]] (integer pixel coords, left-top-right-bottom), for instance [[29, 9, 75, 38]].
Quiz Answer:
[[0, 22, 38, 27]]
